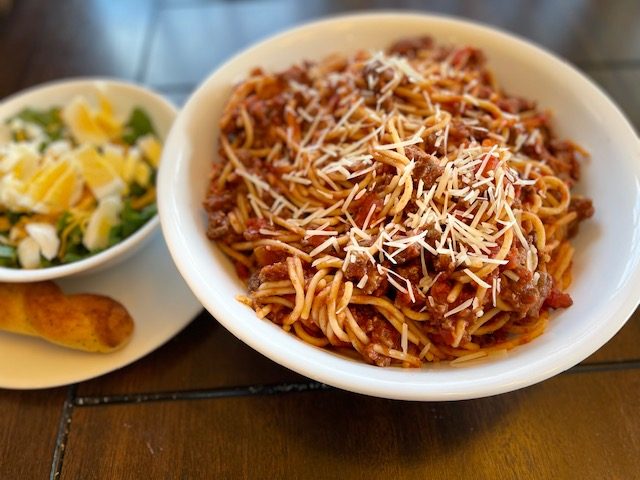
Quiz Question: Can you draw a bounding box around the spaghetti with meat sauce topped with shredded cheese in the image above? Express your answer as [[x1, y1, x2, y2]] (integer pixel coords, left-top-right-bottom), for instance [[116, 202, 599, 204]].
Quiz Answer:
[[204, 38, 593, 367]]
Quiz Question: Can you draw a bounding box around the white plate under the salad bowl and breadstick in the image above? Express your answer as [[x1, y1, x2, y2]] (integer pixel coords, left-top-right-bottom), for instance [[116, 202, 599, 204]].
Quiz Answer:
[[0, 233, 202, 389]]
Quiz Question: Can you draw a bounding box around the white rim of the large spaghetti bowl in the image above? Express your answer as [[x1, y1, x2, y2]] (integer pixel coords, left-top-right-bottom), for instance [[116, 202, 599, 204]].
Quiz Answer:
[[158, 10, 640, 401]]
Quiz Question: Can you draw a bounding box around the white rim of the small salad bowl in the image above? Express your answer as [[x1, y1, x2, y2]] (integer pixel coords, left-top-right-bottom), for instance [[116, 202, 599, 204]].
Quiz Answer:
[[0, 76, 178, 283]]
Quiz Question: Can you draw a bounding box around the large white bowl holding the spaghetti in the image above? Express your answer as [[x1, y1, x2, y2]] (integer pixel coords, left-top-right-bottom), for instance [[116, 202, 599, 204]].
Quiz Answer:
[[159, 12, 640, 400]]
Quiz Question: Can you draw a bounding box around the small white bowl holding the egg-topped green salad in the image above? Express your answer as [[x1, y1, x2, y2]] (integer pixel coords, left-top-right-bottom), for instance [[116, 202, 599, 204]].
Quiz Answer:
[[0, 78, 177, 282]]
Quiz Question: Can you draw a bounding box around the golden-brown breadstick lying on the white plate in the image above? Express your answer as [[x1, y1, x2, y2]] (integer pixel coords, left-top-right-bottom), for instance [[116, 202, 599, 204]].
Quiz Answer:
[[0, 282, 133, 353]]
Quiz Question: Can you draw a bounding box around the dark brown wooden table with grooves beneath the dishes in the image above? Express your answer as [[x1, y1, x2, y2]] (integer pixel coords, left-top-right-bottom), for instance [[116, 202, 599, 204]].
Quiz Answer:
[[0, 0, 640, 479]]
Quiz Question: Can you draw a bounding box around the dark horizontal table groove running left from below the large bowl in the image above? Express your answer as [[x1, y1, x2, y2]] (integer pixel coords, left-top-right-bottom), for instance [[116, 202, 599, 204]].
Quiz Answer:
[[74, 381, 331, 407]]
